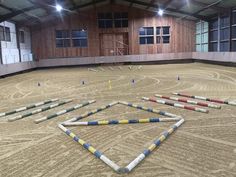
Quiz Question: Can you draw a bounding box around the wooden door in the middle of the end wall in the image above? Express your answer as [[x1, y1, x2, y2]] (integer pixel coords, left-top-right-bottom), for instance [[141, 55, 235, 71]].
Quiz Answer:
[[100, 33, 129, 56]]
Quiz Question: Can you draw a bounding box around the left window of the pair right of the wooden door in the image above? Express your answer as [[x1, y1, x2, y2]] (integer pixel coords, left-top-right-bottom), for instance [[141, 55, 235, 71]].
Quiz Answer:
[[139, 27, 154, 44]]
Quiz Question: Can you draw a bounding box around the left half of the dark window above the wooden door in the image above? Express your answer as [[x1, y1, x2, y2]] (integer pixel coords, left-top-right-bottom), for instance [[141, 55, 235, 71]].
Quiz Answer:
[[98, 13, 113, 28]]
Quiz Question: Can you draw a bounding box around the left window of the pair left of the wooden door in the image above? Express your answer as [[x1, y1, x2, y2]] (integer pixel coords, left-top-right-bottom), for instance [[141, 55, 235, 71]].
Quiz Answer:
[[56, 30, 70, 47]]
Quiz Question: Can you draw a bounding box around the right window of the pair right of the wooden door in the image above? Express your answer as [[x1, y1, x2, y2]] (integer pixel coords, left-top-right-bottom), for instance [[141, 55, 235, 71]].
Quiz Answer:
[[156, 26, 170, 44]]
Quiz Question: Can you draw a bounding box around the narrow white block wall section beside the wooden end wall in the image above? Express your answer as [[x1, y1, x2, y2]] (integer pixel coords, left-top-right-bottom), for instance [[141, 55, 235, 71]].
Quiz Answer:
[[19, 27, 33, 62]]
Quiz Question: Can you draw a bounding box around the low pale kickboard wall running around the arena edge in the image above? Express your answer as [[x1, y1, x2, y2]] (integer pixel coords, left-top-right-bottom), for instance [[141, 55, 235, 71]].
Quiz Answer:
[[0, 52, 236, 76]]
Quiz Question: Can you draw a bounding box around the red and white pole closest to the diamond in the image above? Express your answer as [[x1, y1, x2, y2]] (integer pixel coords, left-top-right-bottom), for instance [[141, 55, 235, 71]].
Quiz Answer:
[[142, 97, 209, 113]]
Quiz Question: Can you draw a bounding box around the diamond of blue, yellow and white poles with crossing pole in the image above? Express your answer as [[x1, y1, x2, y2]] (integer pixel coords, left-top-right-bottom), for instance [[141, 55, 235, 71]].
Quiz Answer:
[[58, 101, 184, 173]]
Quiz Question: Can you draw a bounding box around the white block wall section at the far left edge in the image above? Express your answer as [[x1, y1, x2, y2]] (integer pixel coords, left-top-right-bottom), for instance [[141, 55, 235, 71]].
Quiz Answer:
[[0, 22, 20, 64]]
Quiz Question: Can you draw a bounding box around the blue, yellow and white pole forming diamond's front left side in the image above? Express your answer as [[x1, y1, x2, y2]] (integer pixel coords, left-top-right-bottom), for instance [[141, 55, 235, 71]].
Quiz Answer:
[[58, 124, 120, 172]]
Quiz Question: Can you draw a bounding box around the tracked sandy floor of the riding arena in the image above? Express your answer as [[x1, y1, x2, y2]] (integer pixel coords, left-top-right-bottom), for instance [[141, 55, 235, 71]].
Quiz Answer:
[[0, 63, 236, 177]]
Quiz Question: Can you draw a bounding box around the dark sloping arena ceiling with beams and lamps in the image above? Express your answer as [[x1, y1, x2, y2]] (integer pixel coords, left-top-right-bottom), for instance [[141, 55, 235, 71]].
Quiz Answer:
[[0, 0, 236, 26]]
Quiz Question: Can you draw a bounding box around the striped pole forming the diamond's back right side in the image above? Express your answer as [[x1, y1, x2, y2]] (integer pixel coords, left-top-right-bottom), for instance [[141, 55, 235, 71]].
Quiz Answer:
[[119, 101, 181, 117]]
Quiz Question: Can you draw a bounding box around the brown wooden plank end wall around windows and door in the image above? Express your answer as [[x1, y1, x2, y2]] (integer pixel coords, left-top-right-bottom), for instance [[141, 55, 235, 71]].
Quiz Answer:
[[32, 5, 195, 59]]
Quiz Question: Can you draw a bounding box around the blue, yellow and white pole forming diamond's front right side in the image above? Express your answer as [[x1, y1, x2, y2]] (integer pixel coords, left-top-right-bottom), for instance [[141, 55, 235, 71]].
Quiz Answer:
[[122, 119, 184, 173]]
